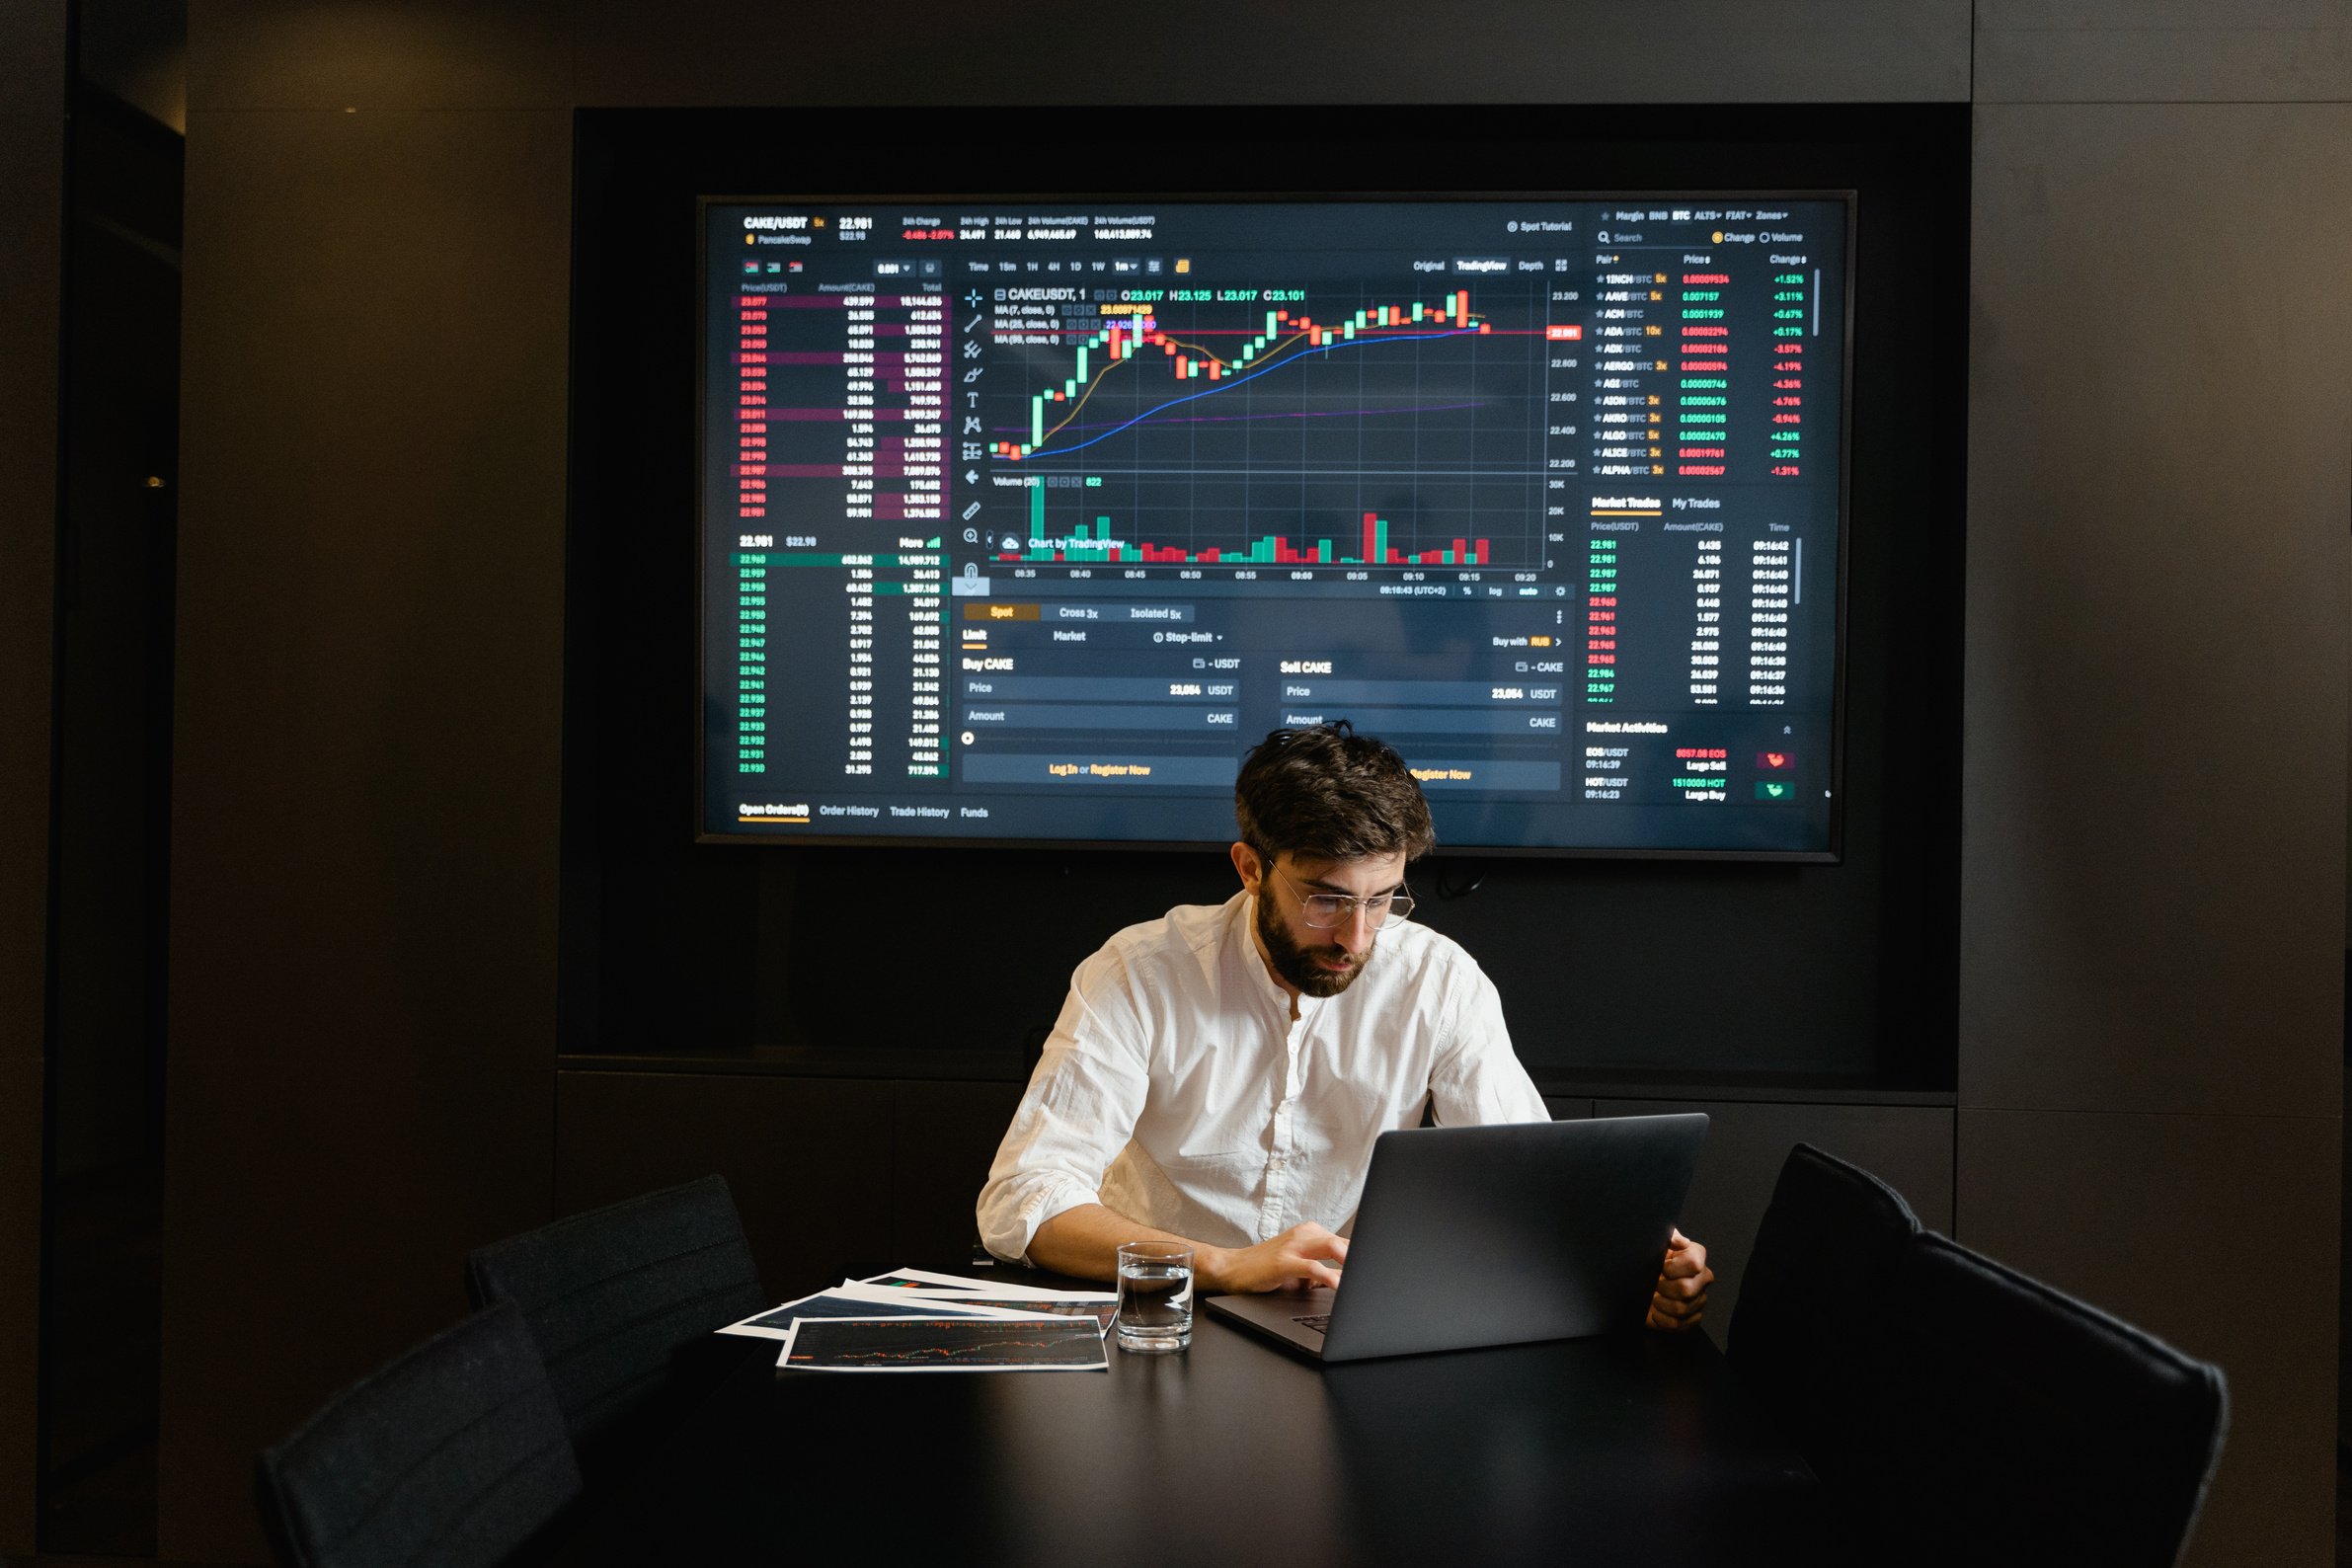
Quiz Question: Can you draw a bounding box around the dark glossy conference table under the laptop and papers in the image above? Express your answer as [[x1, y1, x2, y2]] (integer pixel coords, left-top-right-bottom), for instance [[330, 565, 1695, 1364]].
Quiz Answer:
[[555, 1272, 1825, 1568]]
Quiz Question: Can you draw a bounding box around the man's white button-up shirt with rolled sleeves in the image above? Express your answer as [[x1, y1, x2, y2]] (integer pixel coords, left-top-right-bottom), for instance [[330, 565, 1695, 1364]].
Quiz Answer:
[[979, 894, 1550, 1260]]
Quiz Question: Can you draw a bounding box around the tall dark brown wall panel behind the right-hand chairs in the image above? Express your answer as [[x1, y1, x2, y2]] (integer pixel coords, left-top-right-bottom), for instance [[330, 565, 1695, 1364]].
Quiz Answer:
[[1959, 104, 2352, 1563]]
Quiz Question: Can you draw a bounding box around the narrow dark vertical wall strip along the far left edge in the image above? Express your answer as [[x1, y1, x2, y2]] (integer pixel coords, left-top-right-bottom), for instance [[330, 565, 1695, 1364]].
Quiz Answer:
[[0, 0, 66, 1551]]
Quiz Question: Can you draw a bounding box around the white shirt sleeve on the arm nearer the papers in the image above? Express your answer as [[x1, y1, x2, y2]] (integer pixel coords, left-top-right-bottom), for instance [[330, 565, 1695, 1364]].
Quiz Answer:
[[979, 952, 1150, 1262]]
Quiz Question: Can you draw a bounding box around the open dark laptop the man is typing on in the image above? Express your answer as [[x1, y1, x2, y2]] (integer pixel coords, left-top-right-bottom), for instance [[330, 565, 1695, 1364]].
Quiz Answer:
[[1205, 1115, 1707, 1361]]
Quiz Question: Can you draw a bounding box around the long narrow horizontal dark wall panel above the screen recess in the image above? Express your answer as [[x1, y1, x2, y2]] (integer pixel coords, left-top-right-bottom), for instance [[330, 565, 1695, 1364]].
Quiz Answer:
[[577, 0, 1969, 107]]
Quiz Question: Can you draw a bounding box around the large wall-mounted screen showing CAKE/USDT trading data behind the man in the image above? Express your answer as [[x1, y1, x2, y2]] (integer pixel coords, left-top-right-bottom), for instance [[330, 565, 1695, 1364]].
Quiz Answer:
[[703, 196, 1851, 856]]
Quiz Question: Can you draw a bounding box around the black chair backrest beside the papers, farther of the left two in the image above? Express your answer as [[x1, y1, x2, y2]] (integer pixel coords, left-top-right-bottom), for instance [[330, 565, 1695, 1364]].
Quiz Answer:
[[466, 1175, 769, 1479]]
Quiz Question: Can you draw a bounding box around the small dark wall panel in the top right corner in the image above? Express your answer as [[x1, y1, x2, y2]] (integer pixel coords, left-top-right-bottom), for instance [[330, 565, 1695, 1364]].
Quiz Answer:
[[1976, 0, 2352, 104]]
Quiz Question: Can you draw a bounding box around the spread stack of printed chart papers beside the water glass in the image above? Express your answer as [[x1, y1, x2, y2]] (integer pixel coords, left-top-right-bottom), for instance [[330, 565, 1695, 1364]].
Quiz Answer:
[[720, 1270, 1120, 1372]]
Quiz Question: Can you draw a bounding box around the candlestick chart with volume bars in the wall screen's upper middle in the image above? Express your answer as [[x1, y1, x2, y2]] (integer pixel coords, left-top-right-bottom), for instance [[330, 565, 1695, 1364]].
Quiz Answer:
[[965, 284, 1547, 572]]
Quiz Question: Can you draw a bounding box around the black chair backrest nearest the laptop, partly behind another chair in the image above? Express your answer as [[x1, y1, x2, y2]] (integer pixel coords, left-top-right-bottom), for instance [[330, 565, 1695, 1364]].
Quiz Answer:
[[1726, 1142, 1920, 1481]]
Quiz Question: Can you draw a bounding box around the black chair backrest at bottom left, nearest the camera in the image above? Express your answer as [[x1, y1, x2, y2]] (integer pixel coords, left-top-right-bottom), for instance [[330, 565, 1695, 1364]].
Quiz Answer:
[[261, 1307, 581, 1568]]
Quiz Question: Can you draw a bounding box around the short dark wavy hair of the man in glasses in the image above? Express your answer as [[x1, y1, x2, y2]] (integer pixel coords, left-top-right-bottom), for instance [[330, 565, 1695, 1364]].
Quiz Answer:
[[1232, 720, 1437, 863]]
